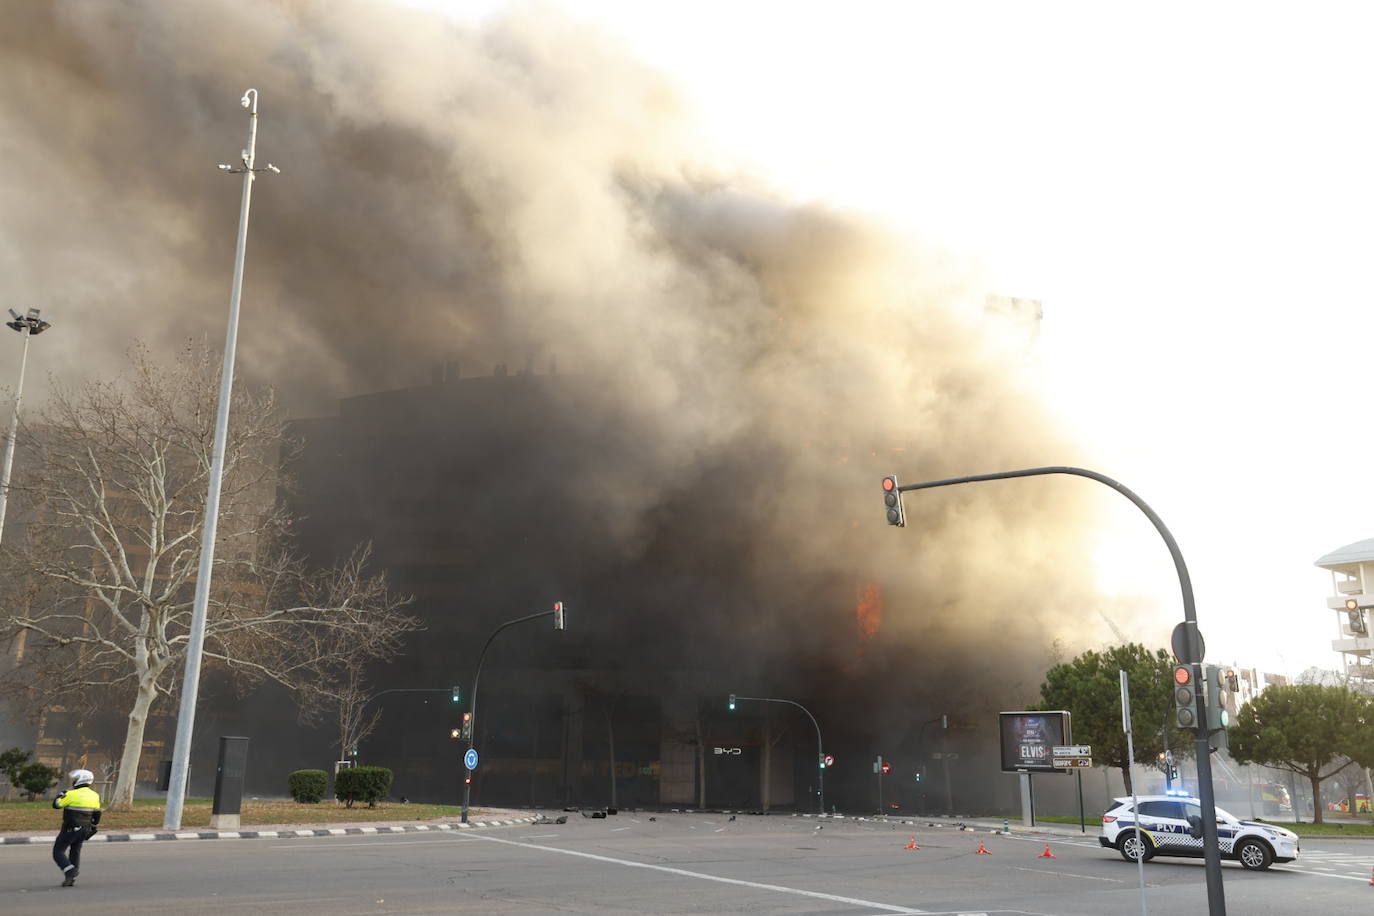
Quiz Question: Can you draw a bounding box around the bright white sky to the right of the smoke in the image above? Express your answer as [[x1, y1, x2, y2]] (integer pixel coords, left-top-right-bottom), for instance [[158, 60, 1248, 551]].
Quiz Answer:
[[409, 0, 1374, 674]]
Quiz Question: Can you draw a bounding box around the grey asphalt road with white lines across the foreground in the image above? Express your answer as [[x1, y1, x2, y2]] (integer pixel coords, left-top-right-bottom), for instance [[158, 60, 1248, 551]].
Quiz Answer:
[[0, 813, 1374, 916]]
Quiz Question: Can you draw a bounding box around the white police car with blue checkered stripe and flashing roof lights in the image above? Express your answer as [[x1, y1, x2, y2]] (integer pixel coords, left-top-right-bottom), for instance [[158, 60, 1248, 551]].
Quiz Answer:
[[1098, 795, 1298, 869]]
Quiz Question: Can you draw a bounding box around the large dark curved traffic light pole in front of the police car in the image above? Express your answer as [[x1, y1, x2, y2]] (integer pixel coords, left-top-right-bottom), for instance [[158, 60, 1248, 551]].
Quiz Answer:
[[897, 467, 1226, 916]]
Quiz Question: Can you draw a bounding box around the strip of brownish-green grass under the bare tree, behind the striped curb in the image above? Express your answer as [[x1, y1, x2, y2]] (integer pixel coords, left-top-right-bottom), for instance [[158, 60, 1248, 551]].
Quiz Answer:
[[0, 798, 481, 834]]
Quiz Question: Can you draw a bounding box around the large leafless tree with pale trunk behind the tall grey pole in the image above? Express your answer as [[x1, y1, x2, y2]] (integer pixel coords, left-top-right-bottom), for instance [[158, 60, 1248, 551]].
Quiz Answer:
[[0, 343, 415, 806]]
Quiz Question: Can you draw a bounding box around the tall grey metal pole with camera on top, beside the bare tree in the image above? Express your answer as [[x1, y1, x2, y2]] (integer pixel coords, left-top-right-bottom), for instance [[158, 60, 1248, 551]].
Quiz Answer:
[[162, 89, 280, 829]]
